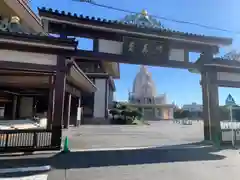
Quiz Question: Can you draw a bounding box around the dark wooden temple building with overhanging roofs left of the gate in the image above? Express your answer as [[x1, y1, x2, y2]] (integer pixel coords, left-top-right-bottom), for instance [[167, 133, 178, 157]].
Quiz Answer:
[[0, 0, 119, 128]]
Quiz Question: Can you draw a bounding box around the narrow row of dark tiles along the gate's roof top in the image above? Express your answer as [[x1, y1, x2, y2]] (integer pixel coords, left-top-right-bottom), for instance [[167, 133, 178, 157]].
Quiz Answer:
[[38, 7, 232, 43]]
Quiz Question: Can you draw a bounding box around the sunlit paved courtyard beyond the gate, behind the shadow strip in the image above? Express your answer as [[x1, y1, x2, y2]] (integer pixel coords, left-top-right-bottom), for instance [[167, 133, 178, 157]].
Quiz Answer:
[[63, 121, 203, 149]]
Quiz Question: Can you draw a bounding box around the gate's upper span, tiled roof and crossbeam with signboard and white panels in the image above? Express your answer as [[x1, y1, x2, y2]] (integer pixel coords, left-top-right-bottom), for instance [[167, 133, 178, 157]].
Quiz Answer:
[[39, 8, 232, 69]]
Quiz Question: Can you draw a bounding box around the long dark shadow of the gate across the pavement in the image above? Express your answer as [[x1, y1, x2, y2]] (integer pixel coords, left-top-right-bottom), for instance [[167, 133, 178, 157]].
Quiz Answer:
[[0, 143, 225, 177]]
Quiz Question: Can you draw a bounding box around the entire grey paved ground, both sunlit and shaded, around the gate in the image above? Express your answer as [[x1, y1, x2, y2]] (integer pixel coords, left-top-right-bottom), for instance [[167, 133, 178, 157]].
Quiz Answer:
[[0, 122, 240, 180]]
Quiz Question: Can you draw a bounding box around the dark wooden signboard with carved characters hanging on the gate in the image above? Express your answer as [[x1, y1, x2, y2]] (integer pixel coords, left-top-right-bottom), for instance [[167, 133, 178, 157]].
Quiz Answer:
[[123, 37, 169, 65]]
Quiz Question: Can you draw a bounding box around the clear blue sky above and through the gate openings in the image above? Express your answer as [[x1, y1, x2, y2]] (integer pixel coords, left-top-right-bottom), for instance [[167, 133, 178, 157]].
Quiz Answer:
[[31, 0, 240, 104]]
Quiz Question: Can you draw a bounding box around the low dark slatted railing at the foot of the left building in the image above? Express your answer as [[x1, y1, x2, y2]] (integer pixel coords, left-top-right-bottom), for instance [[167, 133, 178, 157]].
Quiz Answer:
[[0, 129, 61, 152]]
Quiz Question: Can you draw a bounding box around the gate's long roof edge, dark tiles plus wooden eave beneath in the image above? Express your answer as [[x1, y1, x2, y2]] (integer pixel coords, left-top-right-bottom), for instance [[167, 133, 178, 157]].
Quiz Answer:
[[39, 8, 232, 47]]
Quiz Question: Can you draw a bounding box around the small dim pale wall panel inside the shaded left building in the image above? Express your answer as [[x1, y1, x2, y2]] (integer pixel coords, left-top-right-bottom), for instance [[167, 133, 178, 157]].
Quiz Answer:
[[19, 97, 33, 117]]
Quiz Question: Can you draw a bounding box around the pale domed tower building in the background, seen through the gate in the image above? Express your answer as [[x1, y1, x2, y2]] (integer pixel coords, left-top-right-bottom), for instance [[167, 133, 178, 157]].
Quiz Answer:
[[126, 66, 174, 120]]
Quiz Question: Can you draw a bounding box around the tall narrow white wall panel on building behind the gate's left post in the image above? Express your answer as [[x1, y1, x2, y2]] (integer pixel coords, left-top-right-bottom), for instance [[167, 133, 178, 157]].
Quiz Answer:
[[93, 79, 107, 118]]
